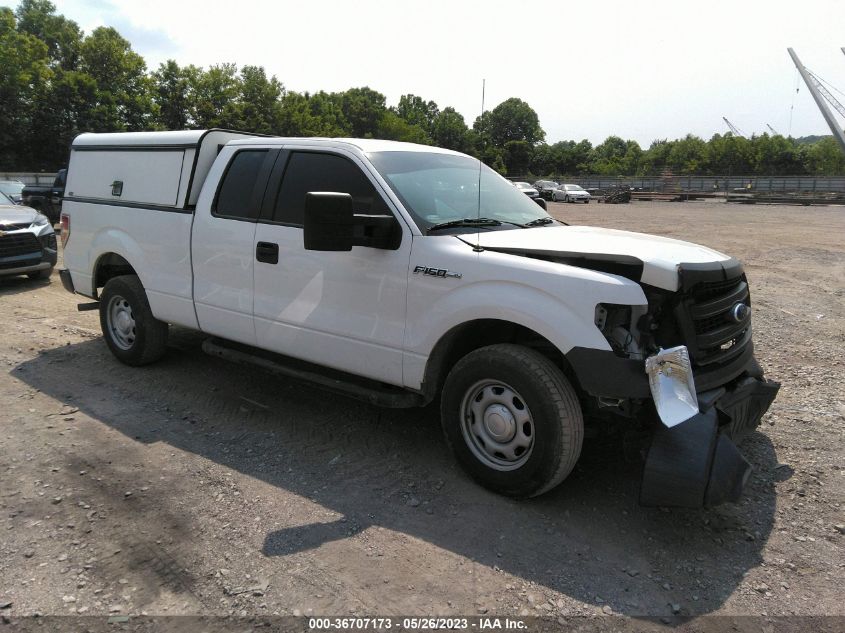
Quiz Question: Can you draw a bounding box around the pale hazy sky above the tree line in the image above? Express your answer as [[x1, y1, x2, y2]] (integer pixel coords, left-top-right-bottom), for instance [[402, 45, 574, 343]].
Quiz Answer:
[[44, 0, 845, 147]]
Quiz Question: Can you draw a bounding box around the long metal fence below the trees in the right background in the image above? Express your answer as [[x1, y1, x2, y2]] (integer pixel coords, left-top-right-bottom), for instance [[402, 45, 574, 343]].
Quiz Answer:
[[536, 176, 845, 193]]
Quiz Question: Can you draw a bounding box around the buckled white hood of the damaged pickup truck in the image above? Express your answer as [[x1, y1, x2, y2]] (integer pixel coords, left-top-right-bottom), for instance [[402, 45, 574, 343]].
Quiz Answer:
[[473, 226, 732, 292]]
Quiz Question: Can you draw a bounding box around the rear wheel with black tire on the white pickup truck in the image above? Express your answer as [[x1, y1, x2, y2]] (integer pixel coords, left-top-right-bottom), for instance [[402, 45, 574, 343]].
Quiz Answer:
[[100, 275, 168, 366]]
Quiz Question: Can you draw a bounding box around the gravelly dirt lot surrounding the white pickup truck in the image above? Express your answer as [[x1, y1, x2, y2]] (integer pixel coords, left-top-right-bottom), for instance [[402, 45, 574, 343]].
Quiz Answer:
[[0, 202, 845, 630]]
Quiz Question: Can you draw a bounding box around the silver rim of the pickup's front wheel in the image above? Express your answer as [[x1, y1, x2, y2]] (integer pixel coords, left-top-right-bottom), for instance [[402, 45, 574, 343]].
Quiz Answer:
[[461, 380, 534, 471]]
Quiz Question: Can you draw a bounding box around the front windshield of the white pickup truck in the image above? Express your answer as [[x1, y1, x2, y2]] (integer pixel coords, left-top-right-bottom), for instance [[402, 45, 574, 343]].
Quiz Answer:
[[369, 152, 548, 232]]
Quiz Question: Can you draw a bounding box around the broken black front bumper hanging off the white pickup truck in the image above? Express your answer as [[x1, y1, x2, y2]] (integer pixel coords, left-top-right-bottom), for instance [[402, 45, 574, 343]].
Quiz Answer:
[[567, 345, 780, 508]]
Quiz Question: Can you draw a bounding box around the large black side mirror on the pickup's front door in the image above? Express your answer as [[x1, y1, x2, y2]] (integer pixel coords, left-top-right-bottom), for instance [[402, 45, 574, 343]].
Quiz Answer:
[[303, 191, 402, 251]]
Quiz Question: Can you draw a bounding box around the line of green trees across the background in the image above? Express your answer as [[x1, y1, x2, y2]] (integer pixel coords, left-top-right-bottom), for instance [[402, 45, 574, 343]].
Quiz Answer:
[[0, 0, 845, 177]]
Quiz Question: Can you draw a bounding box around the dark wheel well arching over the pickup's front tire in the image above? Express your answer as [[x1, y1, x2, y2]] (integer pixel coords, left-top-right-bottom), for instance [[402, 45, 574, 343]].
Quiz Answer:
[[422, 319, 578, 402]]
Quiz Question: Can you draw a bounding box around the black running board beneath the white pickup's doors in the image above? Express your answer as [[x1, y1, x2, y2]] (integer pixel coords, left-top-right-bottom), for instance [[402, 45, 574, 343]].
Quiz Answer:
[[202, 338, 425, 409]]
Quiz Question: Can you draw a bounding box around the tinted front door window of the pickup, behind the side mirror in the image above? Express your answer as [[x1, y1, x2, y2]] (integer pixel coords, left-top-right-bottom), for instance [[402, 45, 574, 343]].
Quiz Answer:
[[273, 152, 390, 226]]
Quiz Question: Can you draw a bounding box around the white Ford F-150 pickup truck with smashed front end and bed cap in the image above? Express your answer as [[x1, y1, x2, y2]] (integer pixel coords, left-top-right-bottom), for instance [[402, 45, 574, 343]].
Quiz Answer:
[[61, 130, 778, 506]]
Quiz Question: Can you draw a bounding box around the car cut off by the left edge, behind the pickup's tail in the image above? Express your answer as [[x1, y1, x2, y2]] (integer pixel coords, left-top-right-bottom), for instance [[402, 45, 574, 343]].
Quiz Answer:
[[0, 188, 58, 279]]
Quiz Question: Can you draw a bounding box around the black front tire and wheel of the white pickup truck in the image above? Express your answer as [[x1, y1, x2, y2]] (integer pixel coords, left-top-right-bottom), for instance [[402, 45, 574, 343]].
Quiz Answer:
[[440, 344, 584, 497]]
